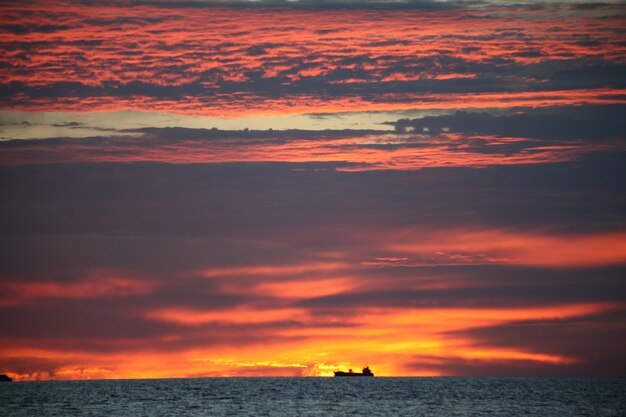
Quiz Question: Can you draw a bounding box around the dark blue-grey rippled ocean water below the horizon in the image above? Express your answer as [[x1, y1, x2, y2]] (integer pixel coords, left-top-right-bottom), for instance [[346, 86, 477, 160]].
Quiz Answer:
[[0, 378, 626, 417]]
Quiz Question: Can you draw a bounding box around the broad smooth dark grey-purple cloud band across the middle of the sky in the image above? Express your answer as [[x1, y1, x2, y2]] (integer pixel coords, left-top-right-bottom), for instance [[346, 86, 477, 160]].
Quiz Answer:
[[0, 153, 624, 236]]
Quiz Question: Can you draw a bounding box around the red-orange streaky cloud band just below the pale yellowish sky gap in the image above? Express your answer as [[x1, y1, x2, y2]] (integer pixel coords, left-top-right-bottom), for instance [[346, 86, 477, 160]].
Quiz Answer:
[[0, 132, 621, 171]]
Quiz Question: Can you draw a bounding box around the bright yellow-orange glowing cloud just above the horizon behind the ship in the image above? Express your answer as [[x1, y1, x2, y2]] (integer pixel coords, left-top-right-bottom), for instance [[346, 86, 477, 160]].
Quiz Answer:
[[0, 303, 624, 380]]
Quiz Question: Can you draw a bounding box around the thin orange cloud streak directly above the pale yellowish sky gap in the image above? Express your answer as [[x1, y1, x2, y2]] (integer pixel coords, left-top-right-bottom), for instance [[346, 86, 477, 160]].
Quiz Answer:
[[0, 88, 626, 118]]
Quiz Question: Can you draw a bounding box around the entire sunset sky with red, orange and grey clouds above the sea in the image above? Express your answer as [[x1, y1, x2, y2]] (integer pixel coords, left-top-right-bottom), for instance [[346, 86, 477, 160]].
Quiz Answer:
[[0, 0, 626, 380]]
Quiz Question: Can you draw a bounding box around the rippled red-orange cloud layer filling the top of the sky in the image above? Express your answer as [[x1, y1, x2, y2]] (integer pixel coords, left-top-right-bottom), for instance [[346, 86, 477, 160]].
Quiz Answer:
[[0, 2, 624, 117]]
